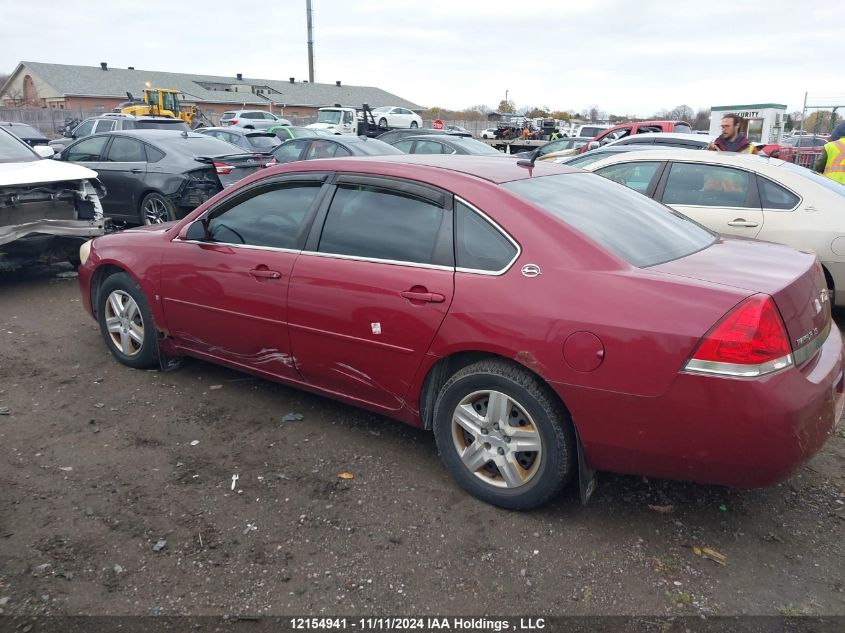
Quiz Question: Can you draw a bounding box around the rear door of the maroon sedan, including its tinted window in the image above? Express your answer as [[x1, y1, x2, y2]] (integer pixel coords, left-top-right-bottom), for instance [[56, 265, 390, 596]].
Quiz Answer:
[[288, 176, 454, 410]]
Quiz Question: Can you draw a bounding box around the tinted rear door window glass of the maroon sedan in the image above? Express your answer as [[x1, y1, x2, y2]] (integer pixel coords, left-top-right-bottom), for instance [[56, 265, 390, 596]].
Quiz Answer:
[[318, 185, 443, 264]]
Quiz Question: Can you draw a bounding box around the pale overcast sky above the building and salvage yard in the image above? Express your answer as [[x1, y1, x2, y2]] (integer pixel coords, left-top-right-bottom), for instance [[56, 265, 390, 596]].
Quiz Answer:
[[0, 0, 845, 116]]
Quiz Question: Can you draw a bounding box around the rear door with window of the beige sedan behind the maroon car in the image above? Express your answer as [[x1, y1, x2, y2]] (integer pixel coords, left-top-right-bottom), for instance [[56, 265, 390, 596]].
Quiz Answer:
[[658, 162, 763, 237]]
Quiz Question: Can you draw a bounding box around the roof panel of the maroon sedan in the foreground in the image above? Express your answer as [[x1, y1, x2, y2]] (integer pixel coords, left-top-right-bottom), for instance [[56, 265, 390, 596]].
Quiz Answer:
[[298, 154, 582, 184]]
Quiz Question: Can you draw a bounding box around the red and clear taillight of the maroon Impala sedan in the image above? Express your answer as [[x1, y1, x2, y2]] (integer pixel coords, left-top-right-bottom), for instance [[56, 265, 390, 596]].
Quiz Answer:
[[684, 295, 793, 377]]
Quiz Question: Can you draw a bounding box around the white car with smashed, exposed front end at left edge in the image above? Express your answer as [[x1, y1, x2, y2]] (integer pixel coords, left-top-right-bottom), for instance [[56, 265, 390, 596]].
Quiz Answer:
[[0, 129, 105, 270]]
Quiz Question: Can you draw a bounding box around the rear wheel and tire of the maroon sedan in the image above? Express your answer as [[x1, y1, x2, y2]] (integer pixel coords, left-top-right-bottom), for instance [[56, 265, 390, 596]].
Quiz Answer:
[[434, 361, 575, 510]]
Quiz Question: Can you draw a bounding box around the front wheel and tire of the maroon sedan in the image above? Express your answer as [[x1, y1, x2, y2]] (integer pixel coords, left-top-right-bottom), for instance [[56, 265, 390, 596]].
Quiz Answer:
[[97, 273, 158, 369]]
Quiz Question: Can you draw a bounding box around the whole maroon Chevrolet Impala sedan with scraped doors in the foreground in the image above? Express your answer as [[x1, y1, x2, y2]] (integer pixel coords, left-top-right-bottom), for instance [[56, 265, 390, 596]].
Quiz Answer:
[[79, 156, 843, 509]]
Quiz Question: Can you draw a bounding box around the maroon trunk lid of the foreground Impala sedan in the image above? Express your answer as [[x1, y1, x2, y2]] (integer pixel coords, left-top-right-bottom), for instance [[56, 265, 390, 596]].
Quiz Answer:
[[651, 238, 831, 364]]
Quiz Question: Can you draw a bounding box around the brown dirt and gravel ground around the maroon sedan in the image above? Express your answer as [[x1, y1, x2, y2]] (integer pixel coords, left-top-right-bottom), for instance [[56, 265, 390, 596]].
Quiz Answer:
[[0, 267, 845, 615]]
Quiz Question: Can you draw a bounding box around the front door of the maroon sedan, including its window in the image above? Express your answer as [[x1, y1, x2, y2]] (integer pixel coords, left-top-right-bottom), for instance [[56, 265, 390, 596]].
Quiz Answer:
[[162, 175, 322, 378]]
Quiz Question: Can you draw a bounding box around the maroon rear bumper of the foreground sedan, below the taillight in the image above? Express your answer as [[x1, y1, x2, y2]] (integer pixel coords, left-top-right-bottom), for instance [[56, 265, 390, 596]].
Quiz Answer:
[[558, 327, 845, 488]]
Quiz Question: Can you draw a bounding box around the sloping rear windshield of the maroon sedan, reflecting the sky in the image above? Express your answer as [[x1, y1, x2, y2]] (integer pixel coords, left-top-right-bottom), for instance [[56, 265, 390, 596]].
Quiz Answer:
[[502, 174, 717, 268]]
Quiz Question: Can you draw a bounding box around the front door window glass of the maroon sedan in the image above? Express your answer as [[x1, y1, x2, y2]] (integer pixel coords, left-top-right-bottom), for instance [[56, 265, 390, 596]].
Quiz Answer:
[[208, 182, 321, 249]]
